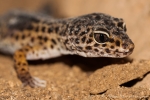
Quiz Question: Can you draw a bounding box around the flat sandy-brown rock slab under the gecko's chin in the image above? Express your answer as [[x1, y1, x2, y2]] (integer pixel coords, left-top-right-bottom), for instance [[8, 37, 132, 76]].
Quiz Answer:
[[89, 61, 150, 94]]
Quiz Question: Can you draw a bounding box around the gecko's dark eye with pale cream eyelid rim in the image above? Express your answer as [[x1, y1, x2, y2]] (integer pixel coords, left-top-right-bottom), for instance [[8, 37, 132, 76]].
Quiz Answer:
[[94, 31, 109, 43]]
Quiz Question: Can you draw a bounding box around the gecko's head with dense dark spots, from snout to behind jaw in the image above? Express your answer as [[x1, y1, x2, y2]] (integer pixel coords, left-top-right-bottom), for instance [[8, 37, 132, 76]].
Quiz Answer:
[[68, 13, 134, 58]]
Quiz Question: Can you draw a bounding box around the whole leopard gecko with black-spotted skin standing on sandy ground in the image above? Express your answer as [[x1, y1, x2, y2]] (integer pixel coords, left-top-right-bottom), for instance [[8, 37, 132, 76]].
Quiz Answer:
[[0, 11, 134, 87]]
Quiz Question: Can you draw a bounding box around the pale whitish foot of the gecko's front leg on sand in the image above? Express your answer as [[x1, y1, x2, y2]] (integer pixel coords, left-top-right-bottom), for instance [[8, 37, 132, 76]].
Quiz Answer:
[[22, 77, 46, 88]]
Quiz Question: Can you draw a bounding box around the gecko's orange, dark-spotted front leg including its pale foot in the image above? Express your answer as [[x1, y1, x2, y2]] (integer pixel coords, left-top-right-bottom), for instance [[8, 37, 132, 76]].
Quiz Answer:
[[14, 46, 46, 87]]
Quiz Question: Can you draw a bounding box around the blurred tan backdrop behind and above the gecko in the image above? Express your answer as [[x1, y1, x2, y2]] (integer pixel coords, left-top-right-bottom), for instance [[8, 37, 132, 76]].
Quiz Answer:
[[0, 0, 150, 60]]
